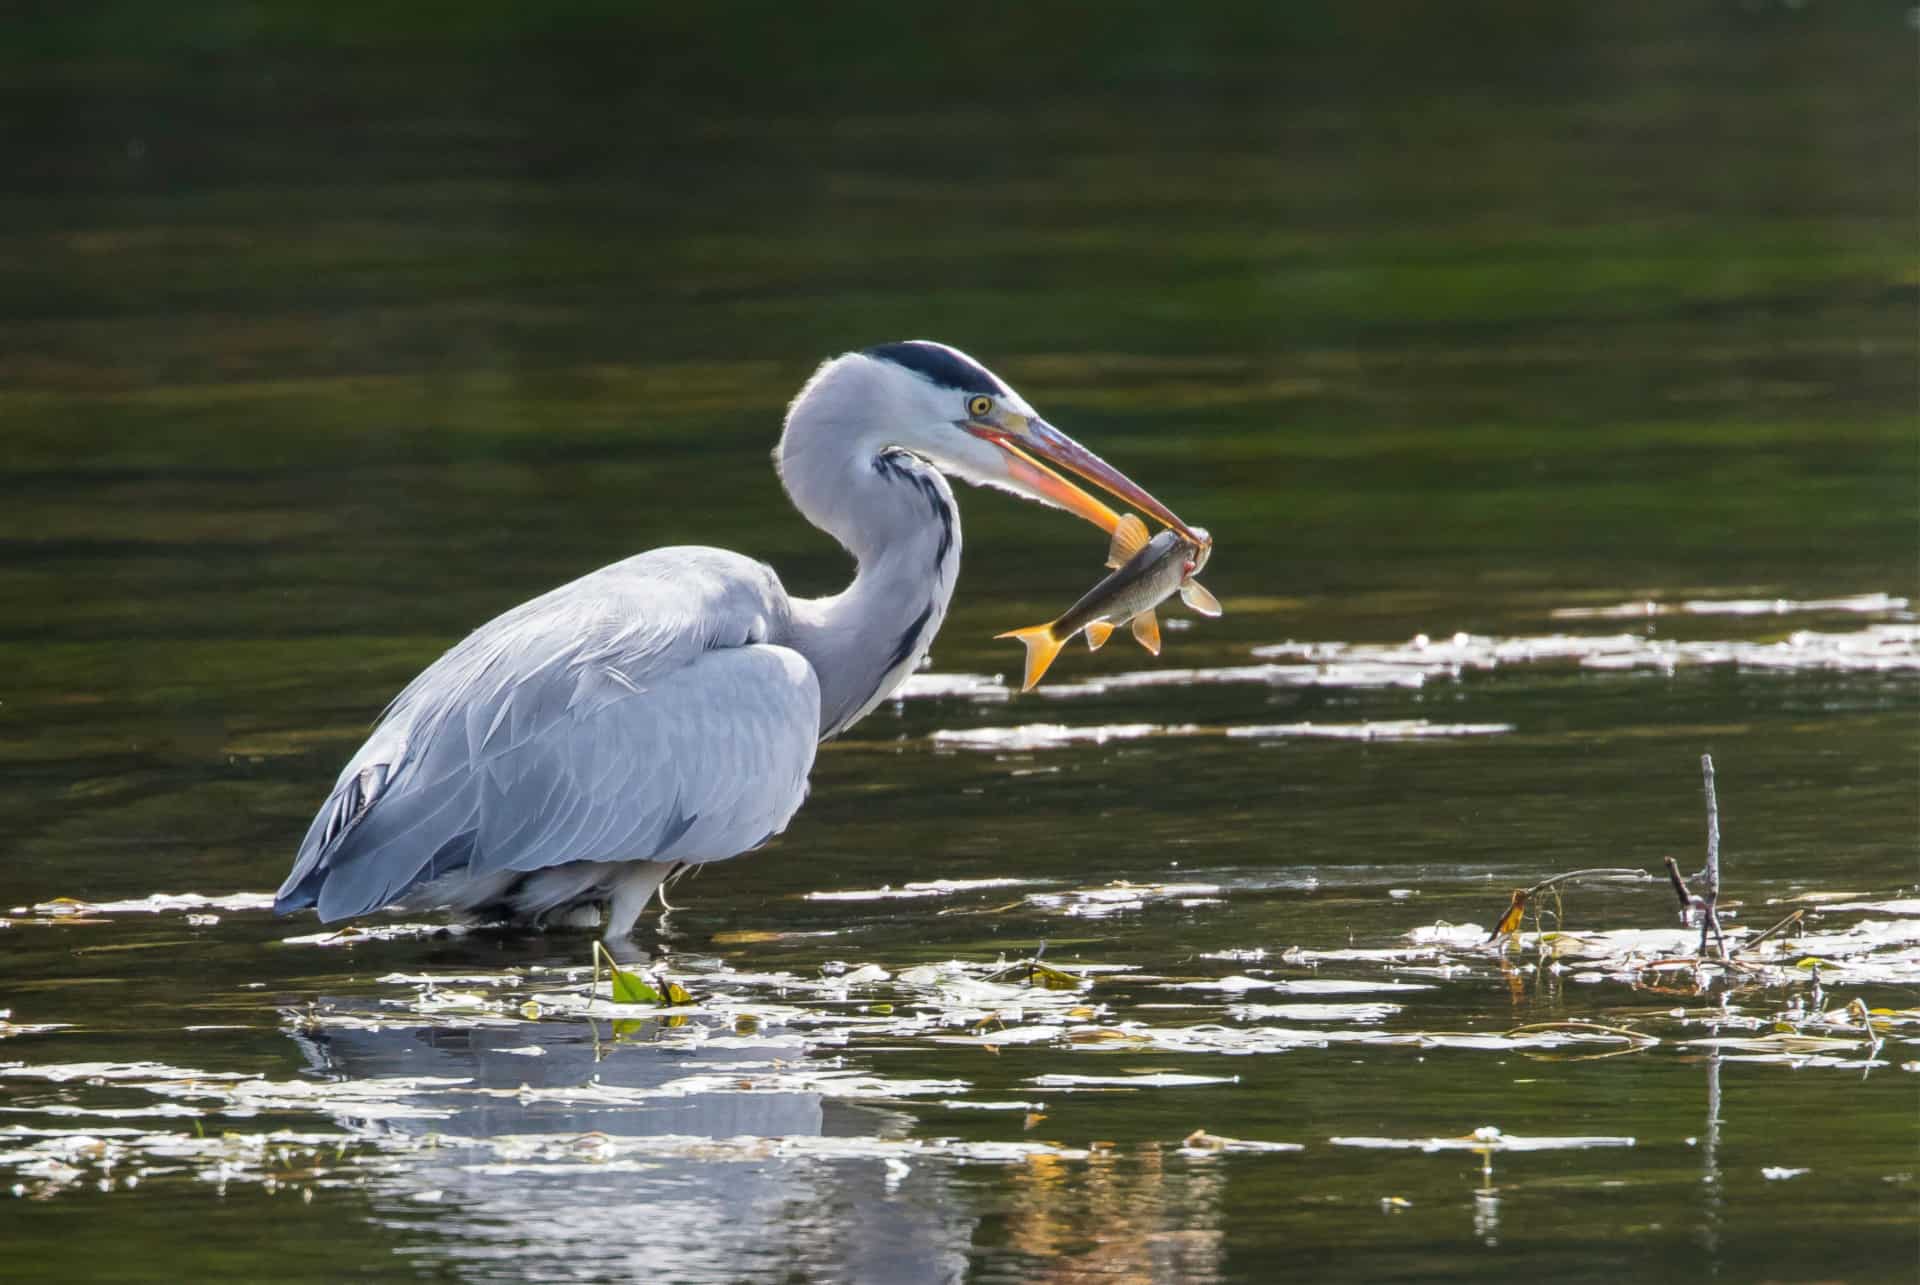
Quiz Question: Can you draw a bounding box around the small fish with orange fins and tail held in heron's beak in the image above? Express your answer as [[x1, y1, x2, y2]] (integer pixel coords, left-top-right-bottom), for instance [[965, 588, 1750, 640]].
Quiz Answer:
[[996, 513, 1219, 691]]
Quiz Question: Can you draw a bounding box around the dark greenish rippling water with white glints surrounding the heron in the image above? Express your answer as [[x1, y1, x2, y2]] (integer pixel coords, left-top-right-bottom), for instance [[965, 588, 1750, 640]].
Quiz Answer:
[[0, 6, 1920, 1281]]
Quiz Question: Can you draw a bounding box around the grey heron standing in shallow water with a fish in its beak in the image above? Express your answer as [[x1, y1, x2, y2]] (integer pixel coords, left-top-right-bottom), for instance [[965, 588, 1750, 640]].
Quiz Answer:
[[275, 340, 1192, 937]]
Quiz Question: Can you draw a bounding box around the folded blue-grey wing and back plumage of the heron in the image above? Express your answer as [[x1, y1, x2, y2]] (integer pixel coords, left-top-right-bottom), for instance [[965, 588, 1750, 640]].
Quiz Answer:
[[276, 549, 820, 920]]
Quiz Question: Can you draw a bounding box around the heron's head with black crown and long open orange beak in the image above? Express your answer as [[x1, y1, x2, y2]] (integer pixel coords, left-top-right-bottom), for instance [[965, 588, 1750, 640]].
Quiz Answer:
[[843, 340, 1206, 544]]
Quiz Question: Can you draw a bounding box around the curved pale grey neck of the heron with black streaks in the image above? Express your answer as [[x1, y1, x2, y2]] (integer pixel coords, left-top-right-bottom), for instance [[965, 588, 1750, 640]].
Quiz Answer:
[[780, 424, 960, 739]]
